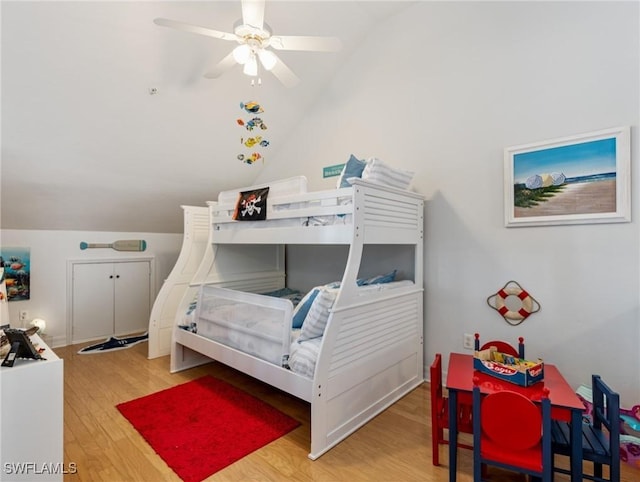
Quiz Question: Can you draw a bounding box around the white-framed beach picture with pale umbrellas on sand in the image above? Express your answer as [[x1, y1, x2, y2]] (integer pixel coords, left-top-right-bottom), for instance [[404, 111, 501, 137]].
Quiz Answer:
[[504, 126, 631, 227]]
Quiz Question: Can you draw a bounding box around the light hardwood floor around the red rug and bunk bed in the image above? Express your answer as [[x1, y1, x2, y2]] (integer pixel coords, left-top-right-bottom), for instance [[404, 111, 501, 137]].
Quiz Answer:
[[55, 343, 640, 482]]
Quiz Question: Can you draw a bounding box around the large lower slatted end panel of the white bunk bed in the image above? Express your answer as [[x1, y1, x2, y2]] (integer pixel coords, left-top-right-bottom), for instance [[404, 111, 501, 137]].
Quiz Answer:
[[309, 289, 423, 459]]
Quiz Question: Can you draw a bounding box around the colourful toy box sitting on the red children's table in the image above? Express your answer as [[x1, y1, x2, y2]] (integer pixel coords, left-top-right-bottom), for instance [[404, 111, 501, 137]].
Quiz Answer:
[[473, 334, 544, 387]]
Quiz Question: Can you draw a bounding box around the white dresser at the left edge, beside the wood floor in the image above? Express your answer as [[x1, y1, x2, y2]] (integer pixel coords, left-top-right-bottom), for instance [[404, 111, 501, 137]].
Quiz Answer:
[[0, 335, 63, 482]]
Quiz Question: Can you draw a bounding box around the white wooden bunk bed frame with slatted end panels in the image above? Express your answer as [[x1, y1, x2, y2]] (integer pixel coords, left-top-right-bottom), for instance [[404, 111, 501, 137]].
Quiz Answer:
[[171, 179, 424, 460]]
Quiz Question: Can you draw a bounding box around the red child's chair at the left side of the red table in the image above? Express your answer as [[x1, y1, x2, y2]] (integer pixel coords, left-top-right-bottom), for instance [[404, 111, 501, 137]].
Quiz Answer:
[[430, 353, 473, 465]]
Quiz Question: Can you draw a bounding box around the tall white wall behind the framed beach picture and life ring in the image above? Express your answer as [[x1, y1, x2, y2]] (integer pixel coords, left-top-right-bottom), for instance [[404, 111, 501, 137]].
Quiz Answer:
[[257, 2, 640, 406]]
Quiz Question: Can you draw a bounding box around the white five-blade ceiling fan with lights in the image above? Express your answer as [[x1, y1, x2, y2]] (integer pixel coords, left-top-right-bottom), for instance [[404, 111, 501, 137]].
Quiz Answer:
[[154, 0, 342, 87]]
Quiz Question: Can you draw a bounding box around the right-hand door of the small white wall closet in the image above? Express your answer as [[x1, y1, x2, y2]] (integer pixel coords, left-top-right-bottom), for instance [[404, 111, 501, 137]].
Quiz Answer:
[[113, 261, 151, 335]]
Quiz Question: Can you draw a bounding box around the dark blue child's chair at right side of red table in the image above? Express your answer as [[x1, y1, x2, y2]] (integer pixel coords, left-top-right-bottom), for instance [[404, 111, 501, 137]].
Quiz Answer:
[[552, 375, 620, 482]]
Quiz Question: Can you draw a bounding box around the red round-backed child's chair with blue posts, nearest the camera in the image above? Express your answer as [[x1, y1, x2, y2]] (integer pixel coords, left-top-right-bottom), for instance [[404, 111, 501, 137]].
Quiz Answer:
[[473, 378, 553, 482]]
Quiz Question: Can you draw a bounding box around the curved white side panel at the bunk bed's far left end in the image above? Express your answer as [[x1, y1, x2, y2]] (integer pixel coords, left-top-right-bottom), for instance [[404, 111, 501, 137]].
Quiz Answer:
[[148, 206, 211, 359]]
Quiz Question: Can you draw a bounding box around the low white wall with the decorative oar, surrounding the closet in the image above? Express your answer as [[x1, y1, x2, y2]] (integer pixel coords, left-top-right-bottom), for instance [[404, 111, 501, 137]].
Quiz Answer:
[[0, 229, 182, 346]]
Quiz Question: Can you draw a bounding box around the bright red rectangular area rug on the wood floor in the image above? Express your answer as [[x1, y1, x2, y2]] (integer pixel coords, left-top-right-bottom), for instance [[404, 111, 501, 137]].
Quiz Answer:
[[117, 376, 300, 482]]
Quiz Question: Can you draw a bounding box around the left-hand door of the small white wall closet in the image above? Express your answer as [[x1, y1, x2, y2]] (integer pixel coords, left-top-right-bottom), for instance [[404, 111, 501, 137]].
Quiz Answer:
[[72, 263, 114, 342]]
